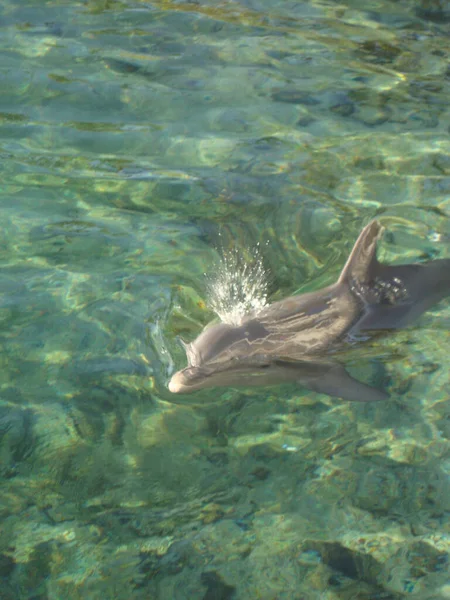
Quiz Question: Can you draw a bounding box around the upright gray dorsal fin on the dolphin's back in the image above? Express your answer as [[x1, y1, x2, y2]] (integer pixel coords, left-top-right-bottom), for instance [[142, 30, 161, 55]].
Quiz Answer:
[[338, 220, 383, 283]]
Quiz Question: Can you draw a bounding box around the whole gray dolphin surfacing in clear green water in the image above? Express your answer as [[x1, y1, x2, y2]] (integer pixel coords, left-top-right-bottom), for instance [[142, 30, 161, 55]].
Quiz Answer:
[[169, 221, 450, 402]]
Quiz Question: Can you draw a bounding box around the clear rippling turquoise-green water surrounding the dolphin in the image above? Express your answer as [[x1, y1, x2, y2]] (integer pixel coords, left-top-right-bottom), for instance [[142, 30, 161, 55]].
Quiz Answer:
[[0, 0, 450, 600]]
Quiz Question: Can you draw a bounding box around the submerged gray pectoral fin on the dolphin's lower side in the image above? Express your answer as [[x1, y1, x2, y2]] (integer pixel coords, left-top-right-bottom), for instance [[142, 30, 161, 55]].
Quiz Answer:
[[276, 360, 389, 402]]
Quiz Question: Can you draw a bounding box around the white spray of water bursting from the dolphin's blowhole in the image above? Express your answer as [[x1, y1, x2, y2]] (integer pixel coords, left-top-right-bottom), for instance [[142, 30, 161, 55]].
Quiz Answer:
[[205, 243, 268, 325]]
